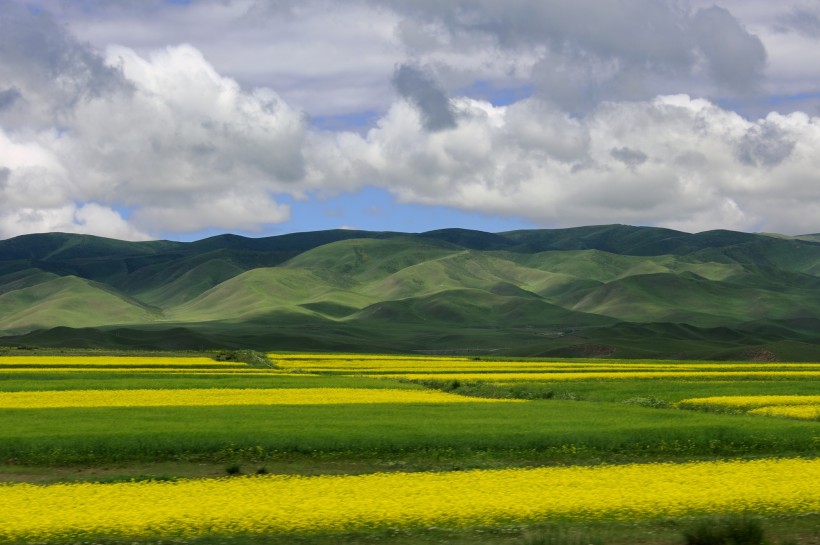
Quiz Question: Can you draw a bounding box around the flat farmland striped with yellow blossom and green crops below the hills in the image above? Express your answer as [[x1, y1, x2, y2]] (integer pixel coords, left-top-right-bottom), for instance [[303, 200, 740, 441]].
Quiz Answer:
[[0, 354, 820, 545]]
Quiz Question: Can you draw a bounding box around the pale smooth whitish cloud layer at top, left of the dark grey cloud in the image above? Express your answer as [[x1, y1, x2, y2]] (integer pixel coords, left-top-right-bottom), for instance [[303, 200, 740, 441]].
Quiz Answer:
[[36, 0, 404, 116]]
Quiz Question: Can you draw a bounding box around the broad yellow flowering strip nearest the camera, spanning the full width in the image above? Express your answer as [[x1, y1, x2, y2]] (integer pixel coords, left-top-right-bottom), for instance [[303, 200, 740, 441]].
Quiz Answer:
[[0, 459, 820, 540]]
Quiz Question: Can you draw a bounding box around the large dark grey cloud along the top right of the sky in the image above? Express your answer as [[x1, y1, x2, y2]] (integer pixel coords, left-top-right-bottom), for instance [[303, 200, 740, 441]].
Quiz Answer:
[[380, 0, 766, 114]]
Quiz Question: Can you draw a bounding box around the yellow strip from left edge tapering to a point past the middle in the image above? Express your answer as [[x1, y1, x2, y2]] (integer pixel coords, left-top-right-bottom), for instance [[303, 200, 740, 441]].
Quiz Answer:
[[0, 388, 523, 409]]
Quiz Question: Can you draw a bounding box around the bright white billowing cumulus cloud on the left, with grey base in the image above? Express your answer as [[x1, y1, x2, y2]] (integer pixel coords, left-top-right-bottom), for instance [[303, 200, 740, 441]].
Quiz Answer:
[[56, 46, 306, 232]]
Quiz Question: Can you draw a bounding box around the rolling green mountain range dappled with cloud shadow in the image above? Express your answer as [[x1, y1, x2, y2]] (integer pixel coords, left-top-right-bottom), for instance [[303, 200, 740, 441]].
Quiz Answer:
[[0, 225, 820, 360]]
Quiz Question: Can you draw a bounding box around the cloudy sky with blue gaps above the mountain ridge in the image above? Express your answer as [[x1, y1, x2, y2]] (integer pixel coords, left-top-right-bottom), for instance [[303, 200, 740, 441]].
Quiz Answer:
[[0, 0, 820, 240]]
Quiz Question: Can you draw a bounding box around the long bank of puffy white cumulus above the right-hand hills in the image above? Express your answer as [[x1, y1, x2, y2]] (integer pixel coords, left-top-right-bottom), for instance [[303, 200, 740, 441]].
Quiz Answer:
[[318, 95, 820, 233]]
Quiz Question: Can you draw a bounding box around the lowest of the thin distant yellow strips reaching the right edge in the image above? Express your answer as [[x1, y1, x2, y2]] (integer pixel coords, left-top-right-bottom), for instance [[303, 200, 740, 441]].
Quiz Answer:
[[384, 370, 820, 382]]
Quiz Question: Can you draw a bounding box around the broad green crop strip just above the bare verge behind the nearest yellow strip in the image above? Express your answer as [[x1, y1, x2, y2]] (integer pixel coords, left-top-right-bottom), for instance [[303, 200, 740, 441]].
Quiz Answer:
[[0, 399, 820, 465]]
